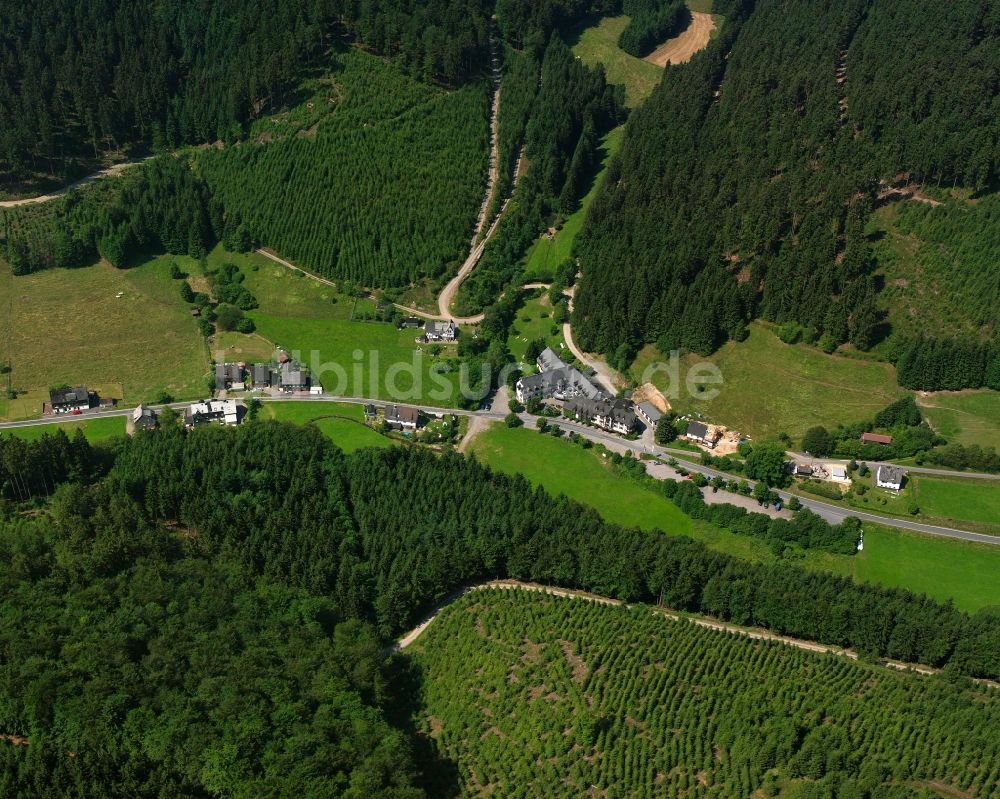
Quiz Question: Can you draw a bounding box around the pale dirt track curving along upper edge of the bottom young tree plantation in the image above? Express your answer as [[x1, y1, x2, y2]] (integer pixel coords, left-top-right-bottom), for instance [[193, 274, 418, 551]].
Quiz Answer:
[[385, 580, 1000, 688]]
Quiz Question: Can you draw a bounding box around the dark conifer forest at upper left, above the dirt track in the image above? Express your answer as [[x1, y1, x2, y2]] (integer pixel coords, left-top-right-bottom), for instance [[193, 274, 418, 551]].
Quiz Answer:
[[0, 0, 490, 187]]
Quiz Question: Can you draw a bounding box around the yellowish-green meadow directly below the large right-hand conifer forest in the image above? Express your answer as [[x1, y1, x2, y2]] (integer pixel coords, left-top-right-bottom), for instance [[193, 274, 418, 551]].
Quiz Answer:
[[631, 324, 904, 440]]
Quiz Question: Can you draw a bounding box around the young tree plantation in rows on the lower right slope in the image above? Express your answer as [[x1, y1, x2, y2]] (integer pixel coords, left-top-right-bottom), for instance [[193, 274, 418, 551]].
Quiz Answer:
[[414, 589, 1000, 799]]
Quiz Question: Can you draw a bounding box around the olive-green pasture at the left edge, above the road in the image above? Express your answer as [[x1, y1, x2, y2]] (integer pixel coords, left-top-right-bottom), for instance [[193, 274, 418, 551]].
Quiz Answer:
[[0, 256, 208, 417]]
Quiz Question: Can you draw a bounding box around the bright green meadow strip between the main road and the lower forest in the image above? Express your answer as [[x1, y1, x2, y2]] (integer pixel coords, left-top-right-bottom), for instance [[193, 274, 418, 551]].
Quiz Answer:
[[469, 422, 1000, 612]]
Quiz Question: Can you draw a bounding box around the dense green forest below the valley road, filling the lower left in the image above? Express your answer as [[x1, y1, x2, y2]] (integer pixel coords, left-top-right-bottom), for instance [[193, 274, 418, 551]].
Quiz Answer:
[[0, 422, 1000, 797]]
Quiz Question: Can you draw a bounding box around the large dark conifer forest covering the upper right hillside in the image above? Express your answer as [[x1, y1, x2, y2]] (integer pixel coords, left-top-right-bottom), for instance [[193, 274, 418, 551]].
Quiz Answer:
[[575, 0, 1000, 370]]
